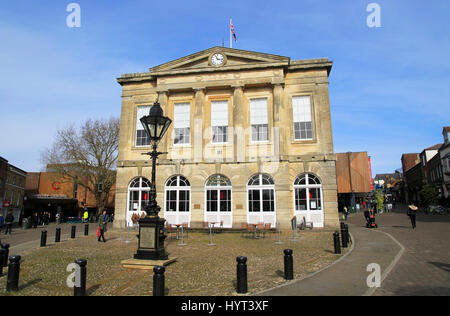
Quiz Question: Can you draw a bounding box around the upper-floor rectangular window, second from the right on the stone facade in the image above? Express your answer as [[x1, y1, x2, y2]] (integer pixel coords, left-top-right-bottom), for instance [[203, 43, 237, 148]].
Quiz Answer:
[[250, 98, 269, 142]]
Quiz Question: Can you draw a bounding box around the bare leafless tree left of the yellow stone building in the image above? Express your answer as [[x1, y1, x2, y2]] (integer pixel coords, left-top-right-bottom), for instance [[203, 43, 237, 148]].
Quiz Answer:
[[41, 118, 120, 212]]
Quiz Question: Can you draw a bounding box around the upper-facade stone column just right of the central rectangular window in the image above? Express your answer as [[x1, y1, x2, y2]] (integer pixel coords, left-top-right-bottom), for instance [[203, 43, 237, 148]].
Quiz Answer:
[[232, 85, 246, 162]]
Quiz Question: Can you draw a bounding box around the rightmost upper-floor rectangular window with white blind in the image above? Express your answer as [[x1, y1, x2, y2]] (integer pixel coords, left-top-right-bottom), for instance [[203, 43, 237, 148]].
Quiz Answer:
[[292, 96, 313, 140]]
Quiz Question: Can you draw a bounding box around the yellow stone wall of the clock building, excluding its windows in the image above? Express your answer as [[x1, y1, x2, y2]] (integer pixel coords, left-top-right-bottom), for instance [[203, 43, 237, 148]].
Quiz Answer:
[[116, 48, 339, 228]]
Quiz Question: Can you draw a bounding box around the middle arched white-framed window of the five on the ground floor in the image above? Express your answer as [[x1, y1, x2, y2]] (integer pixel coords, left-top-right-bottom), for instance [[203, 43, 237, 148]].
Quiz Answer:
[[205, 174, 233, 228]]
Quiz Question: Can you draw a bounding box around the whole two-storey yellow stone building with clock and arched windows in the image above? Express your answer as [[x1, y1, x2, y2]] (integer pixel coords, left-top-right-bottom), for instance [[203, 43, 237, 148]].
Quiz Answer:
[[116, 47, 338, 228]]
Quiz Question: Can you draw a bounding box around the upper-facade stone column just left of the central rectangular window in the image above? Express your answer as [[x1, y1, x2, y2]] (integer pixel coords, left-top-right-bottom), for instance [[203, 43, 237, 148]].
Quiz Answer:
[[193, 87, 206, 162]]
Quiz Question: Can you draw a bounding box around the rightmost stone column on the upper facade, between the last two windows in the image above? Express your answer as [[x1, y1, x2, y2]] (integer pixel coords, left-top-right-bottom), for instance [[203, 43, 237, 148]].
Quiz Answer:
[[273, 84, 289, 159]]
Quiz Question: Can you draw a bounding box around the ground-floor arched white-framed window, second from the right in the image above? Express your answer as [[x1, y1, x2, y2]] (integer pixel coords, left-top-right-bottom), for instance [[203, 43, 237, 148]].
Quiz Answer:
[[247, 174, 276, 227]]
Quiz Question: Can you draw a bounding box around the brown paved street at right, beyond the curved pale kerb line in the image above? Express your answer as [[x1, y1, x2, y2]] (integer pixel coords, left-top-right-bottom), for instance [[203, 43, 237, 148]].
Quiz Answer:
[[349, 205, 450, 296]]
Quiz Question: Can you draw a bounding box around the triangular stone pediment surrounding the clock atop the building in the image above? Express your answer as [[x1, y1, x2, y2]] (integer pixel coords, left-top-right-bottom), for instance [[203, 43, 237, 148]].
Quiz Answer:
[[150, 47, 290, 75]]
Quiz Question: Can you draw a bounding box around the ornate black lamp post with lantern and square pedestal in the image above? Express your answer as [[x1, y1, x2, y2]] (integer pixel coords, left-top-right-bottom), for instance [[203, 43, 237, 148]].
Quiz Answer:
[[134, 101, 172, 260]]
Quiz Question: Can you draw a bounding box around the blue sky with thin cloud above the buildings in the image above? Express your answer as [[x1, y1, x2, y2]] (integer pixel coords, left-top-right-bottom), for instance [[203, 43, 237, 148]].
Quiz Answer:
[[0, 0, 450, 176]]
